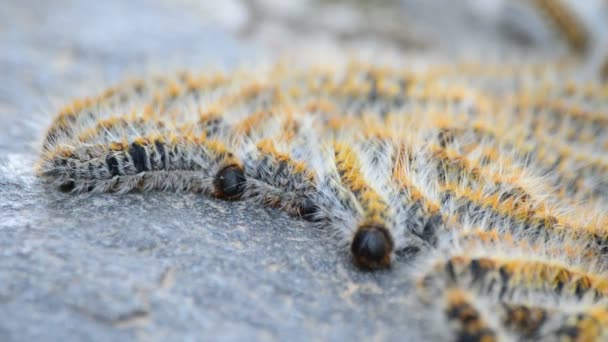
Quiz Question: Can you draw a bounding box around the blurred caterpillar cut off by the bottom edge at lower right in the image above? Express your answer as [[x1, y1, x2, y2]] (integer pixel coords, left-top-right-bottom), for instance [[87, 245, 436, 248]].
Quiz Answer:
[[430, 286, 607, 341]]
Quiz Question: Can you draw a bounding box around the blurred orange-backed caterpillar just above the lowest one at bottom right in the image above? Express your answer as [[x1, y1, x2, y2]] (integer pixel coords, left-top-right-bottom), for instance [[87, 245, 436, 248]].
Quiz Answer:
[[419, 247, 607, 301]]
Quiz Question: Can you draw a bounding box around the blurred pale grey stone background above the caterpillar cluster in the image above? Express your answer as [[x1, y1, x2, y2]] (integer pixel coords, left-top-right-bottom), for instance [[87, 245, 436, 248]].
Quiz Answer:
[[0, 0, 608, 121]]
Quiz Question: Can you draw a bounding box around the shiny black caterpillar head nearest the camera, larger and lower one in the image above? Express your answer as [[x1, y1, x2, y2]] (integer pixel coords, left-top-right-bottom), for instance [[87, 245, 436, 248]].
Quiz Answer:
[[350, 226, 393, 270]]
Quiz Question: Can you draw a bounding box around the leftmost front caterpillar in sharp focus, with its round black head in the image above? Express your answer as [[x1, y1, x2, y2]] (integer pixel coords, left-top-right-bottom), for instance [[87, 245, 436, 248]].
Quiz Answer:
[[40, 134, 244, 199]]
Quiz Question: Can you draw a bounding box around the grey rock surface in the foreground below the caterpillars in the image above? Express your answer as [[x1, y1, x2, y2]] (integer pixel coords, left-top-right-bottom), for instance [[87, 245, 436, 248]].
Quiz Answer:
[[0, 152, 422, 341]]
